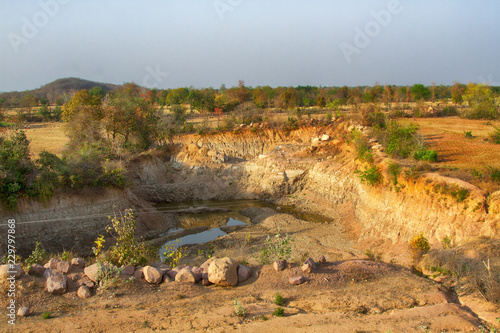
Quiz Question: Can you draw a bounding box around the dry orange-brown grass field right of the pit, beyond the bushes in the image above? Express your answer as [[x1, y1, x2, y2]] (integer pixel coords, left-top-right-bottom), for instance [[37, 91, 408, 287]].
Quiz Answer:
[[400, 117, 500, 169]]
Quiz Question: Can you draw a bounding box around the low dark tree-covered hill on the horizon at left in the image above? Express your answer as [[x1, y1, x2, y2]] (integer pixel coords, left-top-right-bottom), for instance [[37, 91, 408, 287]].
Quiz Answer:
[[0, 77, 121, 105]]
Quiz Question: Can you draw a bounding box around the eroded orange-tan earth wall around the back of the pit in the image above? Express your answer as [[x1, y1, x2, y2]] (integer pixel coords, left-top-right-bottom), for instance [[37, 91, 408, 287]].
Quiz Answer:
[[3, 122, 500, 251]]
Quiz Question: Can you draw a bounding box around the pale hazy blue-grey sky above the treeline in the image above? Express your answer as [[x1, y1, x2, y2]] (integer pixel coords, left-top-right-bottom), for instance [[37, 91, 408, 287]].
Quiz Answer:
[[0, 0, 500, 91]]
